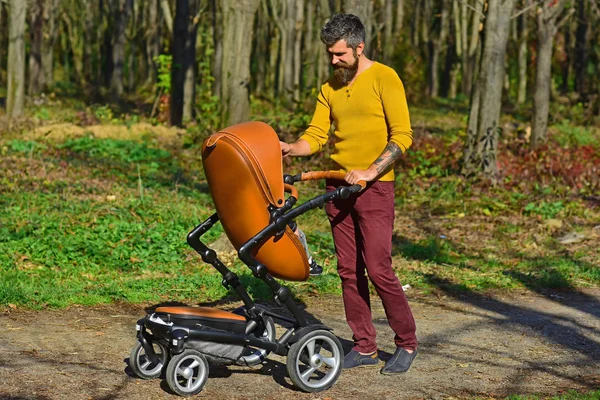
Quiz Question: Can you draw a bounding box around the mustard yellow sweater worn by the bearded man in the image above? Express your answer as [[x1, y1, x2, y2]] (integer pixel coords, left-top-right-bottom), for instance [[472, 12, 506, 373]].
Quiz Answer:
[[300, 62, 412, 181]]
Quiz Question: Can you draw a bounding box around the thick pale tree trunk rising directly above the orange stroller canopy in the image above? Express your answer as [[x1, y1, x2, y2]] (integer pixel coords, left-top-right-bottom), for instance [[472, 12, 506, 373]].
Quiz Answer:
[[221, 0, 259, 125]]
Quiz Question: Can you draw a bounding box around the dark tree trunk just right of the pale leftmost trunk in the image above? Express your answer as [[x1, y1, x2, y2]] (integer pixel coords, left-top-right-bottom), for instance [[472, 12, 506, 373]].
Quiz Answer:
[[27, 0, 46, 96]]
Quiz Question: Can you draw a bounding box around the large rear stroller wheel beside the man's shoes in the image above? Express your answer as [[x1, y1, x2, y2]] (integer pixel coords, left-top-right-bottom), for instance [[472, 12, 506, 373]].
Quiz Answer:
[[286, 329, 344, 393]]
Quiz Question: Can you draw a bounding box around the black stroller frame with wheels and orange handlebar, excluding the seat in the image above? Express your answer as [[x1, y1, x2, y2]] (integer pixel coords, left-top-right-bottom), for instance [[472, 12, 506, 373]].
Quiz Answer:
[[129, 172, 365, 396]]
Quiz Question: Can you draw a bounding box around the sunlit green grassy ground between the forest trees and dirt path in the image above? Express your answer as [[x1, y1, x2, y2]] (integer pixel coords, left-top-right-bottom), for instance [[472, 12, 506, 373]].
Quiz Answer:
[[0, 110, 600, 308]]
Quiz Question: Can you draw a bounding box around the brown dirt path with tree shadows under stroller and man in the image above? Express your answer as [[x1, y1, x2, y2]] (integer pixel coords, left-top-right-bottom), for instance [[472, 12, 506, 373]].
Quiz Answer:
[[0, 289, 600, 400]]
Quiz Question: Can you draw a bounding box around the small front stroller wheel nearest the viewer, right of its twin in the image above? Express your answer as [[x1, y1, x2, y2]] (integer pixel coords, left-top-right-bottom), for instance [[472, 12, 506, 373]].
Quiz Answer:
[[166, 349, 208, 396]]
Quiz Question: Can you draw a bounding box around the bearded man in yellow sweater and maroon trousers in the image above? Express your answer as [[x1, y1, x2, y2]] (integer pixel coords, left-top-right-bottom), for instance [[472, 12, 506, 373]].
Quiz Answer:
[[281, 14, 418, 374]]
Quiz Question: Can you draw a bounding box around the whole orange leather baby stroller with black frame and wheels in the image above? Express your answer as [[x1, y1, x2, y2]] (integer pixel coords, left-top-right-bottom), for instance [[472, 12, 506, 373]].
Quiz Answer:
[[129, 122, 364, 396]]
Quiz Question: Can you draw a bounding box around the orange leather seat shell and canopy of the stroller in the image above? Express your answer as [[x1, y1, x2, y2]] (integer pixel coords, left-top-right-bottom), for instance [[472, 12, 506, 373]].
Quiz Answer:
[[202, 122, 309, 281]]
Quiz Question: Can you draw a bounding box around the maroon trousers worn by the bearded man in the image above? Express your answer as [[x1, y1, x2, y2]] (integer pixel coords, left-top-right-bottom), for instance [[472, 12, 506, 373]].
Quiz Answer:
[[325, 180, 417, 353]]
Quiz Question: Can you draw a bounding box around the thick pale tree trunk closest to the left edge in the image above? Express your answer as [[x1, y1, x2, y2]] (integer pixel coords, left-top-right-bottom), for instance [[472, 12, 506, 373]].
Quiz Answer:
[[6, 0, 27, 118]]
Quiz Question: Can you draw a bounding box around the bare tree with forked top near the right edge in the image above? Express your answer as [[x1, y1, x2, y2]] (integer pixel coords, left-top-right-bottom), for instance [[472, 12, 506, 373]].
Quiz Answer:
[[530, 0, 575, 148]]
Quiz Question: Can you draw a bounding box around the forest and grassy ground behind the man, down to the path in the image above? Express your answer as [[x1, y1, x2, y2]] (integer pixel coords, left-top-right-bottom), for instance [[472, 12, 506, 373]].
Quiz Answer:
[[0, 0, 600, 318]]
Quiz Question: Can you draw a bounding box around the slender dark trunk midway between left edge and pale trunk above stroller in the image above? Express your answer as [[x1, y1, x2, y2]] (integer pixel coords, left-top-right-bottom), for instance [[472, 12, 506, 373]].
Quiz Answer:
[[110, 0, 132, 103]]
